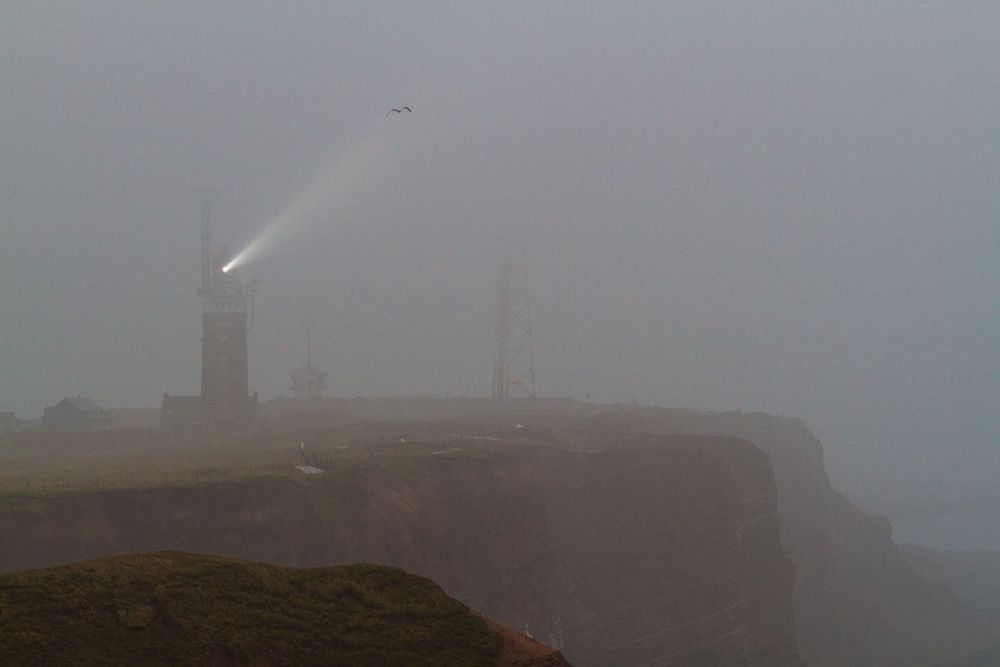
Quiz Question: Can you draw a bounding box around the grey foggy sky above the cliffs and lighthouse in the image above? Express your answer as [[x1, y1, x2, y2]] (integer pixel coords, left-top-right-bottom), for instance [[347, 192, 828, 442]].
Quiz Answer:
[[0, 1, 1000, 500]]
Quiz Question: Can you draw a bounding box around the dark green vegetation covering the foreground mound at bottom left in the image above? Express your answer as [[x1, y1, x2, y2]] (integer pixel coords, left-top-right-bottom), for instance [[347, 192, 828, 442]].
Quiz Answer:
[[0, 552, 501, 667]]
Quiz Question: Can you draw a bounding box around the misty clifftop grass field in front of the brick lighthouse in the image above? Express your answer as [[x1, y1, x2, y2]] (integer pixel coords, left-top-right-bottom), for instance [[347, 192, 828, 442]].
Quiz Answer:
[[0, 422, 529, 495]]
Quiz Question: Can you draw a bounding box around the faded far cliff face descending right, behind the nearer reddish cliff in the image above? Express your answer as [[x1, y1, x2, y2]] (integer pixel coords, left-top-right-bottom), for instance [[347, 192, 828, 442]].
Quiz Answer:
[[561, 409, 1000, 667]]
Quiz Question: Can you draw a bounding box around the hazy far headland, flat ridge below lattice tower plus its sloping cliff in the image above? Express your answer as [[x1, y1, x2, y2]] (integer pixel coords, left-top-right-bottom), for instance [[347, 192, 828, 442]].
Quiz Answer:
[[252, 399, 1000, 667]]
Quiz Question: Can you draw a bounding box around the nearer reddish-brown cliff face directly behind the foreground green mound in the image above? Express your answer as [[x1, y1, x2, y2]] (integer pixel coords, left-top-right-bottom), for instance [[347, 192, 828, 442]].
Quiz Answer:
[[0, 436, 801, 666]]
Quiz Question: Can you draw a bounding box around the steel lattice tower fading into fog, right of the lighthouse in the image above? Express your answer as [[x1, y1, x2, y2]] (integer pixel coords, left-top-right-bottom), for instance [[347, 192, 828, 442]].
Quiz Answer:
[[493, 247, 536, 399]]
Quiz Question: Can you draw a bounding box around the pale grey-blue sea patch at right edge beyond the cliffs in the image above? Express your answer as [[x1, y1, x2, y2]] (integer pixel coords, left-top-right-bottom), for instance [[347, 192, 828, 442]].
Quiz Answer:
[[889, 504, 1000, 551]]
